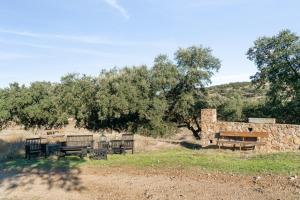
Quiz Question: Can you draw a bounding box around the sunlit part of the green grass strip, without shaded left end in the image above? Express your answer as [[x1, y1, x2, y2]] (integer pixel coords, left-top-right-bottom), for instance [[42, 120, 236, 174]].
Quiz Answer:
[[87, 149, 300, 175]]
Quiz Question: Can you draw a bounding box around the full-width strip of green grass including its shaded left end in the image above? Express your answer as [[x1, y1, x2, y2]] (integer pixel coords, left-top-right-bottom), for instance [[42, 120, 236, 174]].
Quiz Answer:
[[0, 149, 300, 175]]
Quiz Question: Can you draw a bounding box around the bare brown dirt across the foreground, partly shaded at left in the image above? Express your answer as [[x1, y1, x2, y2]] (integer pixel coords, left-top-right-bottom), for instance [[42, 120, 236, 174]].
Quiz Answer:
[[0, 167, 300, 200]]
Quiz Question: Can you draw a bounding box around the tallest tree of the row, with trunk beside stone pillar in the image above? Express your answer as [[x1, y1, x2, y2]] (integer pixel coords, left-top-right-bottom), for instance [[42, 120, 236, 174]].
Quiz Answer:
[[170, 46, 221, 138]]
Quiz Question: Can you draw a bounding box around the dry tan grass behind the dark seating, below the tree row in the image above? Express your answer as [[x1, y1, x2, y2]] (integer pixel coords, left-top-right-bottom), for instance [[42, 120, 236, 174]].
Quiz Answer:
[[0, 126, 188, 160]]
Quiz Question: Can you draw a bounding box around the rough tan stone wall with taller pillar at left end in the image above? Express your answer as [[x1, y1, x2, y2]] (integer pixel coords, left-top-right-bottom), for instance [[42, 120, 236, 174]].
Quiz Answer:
[[201, 109, 300, 152]]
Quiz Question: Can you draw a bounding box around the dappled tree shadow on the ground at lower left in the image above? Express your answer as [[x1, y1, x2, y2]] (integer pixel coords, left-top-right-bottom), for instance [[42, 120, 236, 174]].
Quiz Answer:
[[0, 141, 85, 192]]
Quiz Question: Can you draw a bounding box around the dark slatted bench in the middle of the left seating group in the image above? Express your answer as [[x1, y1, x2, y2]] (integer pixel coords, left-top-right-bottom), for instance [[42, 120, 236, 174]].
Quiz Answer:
[[59, 135, 94, 158]]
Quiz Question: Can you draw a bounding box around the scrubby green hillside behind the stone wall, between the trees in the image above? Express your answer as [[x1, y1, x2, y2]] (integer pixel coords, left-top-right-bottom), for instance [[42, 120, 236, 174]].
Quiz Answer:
[[207, 82, 267, 121]]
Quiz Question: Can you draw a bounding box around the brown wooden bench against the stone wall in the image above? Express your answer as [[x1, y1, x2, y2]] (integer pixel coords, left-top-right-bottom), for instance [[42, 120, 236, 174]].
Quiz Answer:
[[217, 131, 268, 150]]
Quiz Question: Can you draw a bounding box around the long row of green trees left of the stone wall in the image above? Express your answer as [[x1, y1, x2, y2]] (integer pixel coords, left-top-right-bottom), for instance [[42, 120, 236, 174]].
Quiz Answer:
[[0, 46, 220, 137]]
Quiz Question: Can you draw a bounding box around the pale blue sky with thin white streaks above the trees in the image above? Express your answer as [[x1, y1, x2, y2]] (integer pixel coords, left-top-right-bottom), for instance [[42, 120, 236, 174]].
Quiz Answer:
[[0, 0, 300, 87]]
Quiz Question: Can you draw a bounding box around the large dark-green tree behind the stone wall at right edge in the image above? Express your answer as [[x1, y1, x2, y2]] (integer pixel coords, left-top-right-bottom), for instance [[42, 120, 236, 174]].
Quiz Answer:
[[247, 30, 300, 122]]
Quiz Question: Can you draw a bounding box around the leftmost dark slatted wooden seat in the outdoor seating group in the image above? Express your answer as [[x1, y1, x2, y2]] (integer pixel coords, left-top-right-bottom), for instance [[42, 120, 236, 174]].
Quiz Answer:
[[25, 138, 42, 160]]
